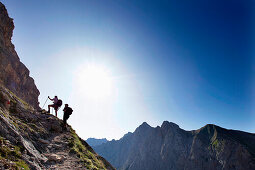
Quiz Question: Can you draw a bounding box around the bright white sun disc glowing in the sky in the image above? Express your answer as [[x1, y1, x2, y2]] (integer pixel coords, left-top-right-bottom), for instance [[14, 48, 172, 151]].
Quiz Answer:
[[76, 64, 113, 100]]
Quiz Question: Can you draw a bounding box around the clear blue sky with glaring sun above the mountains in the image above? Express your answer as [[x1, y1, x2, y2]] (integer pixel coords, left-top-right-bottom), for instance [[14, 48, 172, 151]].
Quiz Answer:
[[1, 0, 255, 139]]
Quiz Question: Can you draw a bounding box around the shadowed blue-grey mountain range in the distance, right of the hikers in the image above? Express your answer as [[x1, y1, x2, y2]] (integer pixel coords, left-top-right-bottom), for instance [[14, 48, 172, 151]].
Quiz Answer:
[[93, 121, 255, 170]]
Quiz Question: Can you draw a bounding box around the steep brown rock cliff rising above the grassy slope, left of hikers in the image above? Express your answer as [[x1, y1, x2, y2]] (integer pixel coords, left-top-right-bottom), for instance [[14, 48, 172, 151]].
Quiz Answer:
[[0, 2, 40, 109]]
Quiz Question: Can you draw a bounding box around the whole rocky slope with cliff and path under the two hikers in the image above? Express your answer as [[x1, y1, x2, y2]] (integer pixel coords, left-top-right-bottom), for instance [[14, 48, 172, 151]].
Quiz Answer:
[[0, 3, 114, 170]]
